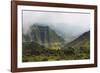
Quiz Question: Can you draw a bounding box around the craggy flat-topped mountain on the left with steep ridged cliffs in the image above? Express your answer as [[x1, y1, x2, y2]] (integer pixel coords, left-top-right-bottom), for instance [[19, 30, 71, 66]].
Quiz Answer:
[[23, 24, 65, 49]]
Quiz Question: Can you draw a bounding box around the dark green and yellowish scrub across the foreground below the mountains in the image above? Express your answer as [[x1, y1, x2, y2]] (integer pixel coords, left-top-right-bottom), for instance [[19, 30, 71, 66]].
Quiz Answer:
[[23, 42, 89, 62]]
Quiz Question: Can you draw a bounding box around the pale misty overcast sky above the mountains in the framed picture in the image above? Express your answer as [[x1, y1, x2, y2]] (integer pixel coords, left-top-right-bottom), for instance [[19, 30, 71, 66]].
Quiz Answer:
[[23, 11, 90, 42]]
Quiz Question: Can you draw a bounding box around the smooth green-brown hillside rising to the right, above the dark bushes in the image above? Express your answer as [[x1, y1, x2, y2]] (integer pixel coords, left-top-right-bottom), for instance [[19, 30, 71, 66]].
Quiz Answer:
[[64, 31, 90, 48]]
